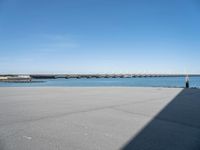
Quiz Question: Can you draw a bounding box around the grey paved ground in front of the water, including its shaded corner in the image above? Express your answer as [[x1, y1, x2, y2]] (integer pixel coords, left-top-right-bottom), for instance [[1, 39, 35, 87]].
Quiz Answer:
[[0, 88, 200, 150]]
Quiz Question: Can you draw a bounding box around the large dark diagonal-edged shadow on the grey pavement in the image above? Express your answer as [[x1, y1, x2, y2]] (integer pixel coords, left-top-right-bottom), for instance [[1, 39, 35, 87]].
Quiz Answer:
[[122, 89, 200, 150]]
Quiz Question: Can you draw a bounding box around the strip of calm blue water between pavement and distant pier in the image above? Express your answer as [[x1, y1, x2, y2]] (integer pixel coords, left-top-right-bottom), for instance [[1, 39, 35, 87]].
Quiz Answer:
[[0, 76, 200, 88]]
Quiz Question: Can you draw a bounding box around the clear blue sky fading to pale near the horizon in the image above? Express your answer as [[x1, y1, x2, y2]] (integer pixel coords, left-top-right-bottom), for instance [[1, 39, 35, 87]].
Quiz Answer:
[[0, 0, 200, 73]]
